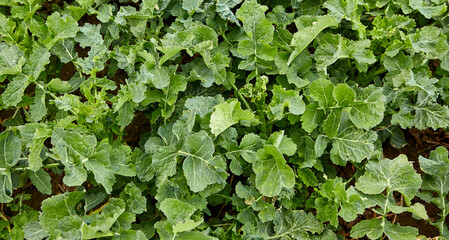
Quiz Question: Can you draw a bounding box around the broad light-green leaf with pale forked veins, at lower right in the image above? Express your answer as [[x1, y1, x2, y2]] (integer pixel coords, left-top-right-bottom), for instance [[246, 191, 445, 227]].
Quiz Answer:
[[355, 155, 422, 202]]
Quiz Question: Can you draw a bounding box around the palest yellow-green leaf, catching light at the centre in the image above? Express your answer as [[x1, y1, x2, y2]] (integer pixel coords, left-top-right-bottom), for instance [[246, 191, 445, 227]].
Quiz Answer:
[[209, 99, 254, 136]]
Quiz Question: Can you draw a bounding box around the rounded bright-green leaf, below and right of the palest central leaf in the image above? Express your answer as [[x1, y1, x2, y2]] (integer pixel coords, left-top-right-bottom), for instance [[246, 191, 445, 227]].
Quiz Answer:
[[253, 145, 295, 197]]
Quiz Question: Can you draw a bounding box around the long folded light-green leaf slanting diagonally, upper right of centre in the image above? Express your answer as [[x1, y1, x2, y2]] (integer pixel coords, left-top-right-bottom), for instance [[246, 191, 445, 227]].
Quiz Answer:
[[287, 15, 338, 65]]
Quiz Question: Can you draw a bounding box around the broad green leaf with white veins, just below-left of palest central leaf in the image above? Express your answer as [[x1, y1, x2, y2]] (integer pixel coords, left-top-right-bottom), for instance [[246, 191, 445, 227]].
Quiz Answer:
[[178, 131, 228, 192]]
